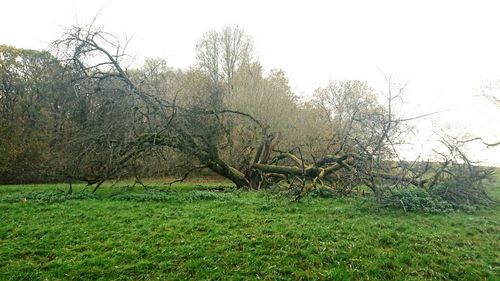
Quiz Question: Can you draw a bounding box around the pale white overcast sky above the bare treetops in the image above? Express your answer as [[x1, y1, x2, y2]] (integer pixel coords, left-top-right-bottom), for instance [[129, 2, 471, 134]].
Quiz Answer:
[[0, 0, 500, 166]]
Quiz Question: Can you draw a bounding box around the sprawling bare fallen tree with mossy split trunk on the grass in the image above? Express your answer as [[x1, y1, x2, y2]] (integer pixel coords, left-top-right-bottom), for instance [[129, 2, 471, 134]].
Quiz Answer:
[[50, 26, 492, 201]]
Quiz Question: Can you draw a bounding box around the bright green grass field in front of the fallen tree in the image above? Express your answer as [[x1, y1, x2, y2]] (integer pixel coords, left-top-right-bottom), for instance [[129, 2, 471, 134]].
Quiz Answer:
[[0, 175, 500, 280]]
